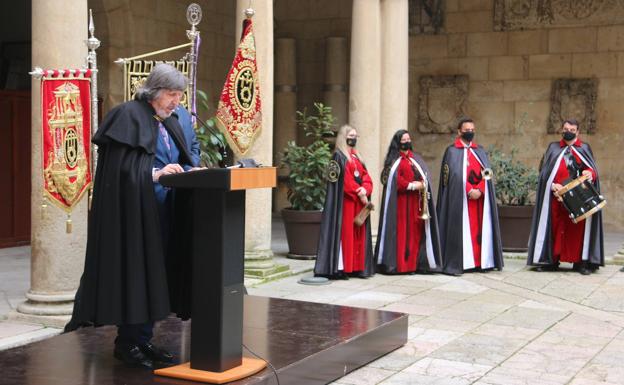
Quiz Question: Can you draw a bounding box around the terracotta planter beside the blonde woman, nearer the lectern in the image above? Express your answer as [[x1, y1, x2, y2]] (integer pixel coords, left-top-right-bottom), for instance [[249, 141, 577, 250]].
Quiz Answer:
[[282, 209, 321, 259]]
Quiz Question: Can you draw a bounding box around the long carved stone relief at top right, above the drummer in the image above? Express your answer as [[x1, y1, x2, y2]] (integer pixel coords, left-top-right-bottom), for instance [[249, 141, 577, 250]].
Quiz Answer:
[[494, 0, 624, 31]]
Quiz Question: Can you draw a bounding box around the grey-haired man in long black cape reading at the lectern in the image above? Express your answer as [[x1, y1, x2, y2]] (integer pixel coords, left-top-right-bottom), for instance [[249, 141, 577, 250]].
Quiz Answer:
[[65, 64, 194, 368]]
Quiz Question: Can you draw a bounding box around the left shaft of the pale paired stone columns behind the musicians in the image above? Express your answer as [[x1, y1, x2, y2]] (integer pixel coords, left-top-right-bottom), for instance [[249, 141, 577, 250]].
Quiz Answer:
[[349, 0, 383, 228]]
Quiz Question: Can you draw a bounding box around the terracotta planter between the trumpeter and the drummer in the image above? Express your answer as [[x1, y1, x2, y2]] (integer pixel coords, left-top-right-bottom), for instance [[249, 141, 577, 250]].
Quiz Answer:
[[498, 205, 535, 252]]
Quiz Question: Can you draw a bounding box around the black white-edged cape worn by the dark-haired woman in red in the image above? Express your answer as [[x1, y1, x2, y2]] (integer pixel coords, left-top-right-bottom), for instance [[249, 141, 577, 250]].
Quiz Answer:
[[375, 154, 443, 274]]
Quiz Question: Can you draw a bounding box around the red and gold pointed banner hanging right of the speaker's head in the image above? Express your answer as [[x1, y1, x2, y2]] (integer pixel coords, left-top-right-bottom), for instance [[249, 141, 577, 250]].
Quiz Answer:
[[217, 19, 262, 155]]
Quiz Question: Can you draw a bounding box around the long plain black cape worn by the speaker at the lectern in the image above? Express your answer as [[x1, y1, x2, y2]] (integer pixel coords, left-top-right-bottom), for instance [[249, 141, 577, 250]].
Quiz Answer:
[[66, 97, 192, 330]]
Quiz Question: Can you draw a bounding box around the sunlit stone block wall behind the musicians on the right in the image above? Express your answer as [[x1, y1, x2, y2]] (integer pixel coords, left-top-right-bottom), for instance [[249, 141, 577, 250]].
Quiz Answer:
[[409, 0, 624, 229]]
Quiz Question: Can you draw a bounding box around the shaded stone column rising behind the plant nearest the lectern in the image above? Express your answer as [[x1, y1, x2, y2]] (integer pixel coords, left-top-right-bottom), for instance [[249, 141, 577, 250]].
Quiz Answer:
[[273, 38, 297, 213]]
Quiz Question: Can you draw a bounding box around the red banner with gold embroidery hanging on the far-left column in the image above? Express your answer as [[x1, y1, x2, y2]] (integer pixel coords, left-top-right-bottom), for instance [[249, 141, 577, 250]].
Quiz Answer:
[[41, 77, 91, 213]]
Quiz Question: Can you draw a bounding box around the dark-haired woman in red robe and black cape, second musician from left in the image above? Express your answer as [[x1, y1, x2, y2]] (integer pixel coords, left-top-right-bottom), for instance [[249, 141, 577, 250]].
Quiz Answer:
[[375, 130, 442, 274]]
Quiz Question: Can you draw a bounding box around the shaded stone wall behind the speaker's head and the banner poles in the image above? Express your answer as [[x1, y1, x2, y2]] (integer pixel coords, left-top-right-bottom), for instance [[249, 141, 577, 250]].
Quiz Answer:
[[88, 0, 234, 114]]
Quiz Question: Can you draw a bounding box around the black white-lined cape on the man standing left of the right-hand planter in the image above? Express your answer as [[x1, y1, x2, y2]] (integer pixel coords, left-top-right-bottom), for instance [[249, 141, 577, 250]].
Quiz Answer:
[[437, 144, 503, 274]]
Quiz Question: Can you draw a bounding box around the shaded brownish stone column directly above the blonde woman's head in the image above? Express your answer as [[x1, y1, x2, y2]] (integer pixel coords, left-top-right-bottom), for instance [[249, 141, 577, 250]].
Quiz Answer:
[[323, 37, 348, 128]]
